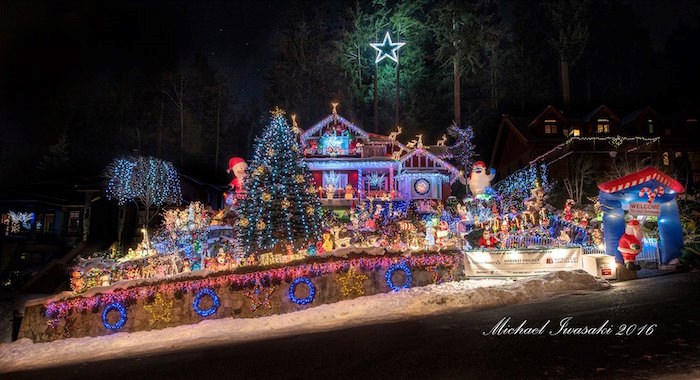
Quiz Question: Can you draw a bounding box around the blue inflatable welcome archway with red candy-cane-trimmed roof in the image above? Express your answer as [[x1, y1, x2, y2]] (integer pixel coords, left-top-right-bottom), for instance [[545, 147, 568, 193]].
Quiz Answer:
[[598, 167, 685, 264]]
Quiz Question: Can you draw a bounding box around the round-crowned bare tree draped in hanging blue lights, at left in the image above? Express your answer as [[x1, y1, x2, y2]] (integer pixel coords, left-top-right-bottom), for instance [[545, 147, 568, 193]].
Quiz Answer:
[[105, 156, 182, 224]]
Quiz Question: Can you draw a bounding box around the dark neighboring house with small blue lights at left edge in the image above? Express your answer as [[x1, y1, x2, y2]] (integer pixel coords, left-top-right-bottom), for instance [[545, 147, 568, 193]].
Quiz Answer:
[[0, 177, 117, 290]]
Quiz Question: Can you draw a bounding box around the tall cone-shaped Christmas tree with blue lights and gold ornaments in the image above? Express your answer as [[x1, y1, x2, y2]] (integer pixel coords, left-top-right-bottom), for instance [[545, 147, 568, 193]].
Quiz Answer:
[[236, 108, 321, 255]]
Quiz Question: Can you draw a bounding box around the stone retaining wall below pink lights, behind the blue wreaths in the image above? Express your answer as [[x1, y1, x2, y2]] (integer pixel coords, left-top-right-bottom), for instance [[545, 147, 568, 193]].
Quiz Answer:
[[19, 260, 459, 342]]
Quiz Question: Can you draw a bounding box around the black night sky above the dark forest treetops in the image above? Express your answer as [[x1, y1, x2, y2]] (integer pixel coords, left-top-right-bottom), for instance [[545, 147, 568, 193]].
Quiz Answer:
[[0, 0, 700, 181]]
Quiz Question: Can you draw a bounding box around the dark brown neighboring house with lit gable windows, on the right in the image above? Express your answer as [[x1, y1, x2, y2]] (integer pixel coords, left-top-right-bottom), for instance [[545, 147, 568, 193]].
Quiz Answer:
[[491, 105, 700, 191]]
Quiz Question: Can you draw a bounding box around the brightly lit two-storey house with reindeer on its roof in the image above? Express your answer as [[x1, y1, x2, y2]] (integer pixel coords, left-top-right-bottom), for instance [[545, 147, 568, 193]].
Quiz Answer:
[[295, 107, 464, 207]]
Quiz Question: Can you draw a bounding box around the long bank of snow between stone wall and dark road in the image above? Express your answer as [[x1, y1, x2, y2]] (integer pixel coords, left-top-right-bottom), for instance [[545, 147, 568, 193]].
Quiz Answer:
[[0, 270, 610, 373]]
